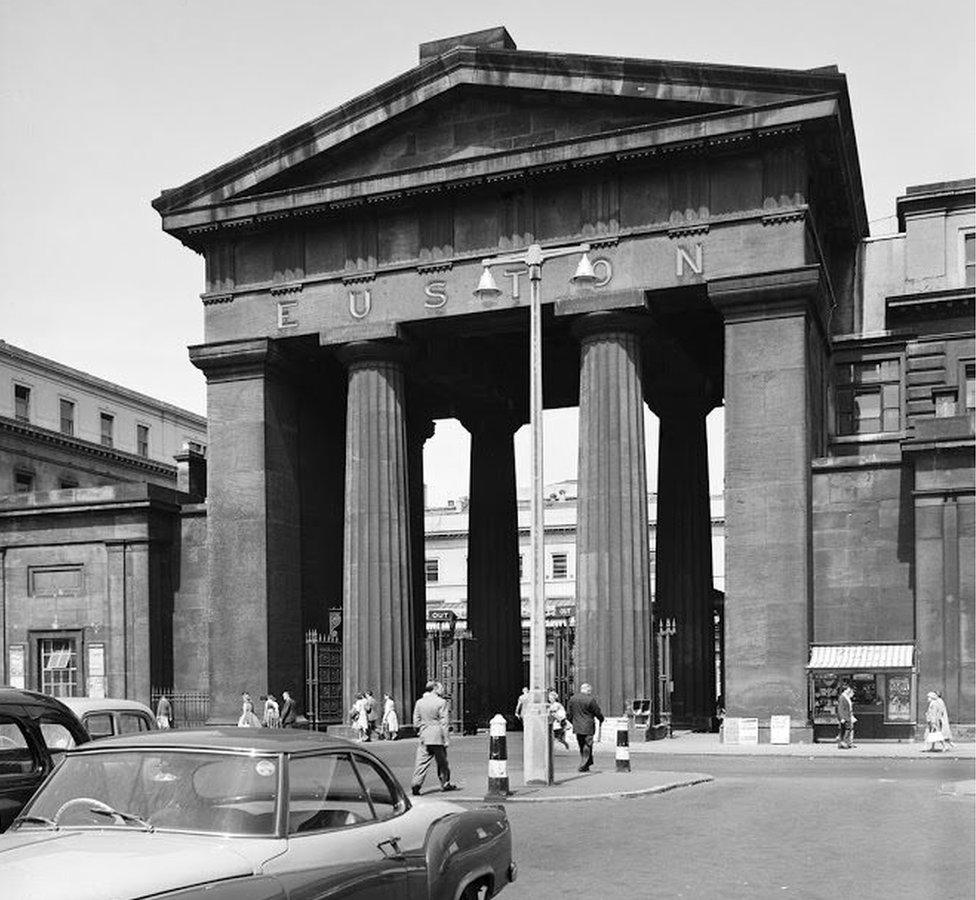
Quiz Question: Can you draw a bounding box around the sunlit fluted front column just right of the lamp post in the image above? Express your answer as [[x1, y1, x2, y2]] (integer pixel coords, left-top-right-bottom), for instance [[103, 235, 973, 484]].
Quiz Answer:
[[575, 313, 653, 715]]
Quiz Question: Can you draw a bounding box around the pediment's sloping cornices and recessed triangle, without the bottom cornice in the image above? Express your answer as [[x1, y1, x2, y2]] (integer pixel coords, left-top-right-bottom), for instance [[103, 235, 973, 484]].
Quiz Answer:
[[153, 47, 846, 227]]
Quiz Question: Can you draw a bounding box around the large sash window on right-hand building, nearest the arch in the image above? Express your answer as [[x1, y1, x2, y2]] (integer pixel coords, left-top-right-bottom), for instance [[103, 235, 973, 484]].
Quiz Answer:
[[836, 359, 901, 435]]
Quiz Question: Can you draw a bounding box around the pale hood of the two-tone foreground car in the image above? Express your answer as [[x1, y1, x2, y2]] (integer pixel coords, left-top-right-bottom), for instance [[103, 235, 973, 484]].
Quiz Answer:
[[0, 829, 278, 900]]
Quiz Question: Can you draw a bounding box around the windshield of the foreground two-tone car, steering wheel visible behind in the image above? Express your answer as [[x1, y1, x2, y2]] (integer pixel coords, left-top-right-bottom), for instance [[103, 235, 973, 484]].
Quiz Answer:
[[17, 749, 279, 836]]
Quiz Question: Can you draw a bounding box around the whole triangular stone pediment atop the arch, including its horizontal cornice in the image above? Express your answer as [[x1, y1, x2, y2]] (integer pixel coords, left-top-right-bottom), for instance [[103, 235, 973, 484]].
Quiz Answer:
[[153, 37, 849, 235]]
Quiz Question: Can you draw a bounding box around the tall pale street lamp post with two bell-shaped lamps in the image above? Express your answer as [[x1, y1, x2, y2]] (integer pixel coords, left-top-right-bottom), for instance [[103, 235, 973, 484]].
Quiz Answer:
[[475, 244, 597, 784]]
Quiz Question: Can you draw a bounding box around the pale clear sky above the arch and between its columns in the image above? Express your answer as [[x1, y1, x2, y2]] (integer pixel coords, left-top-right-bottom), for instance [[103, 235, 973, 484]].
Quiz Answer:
[[0, 0, 976, 500]]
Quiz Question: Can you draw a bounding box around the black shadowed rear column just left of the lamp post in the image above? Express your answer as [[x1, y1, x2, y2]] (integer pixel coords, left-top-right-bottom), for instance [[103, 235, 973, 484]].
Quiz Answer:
[[464, 413, 522, 724]]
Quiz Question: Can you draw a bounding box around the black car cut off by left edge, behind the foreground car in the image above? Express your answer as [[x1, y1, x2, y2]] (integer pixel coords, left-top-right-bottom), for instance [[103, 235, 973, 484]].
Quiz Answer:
[[0, 685, 88, 831]]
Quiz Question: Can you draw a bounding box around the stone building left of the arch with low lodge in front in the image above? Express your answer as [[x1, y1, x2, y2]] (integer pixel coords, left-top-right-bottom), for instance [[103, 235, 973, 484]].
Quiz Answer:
[[0, 342, 207, 702]]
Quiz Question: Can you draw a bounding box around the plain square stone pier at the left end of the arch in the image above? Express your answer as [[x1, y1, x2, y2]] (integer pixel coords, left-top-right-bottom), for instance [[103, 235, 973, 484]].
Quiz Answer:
[[188, 338, 304, 722]]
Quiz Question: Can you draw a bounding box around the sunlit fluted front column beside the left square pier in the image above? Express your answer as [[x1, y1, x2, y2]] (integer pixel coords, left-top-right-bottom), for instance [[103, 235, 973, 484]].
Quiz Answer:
[[339, 342, 415, 717]]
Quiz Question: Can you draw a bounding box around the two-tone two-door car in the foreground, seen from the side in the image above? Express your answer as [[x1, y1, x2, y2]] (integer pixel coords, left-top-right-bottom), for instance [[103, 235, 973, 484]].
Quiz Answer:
[[0, 728, 516, 900]]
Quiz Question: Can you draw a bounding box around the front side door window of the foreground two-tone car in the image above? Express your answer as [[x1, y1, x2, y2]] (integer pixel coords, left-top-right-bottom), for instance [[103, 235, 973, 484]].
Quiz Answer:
[[288, 753, 373, 834]]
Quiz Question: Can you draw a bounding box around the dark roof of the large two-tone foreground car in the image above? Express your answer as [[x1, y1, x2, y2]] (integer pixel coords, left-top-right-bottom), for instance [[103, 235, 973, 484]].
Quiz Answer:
[[73, 725, 359, 753]]
